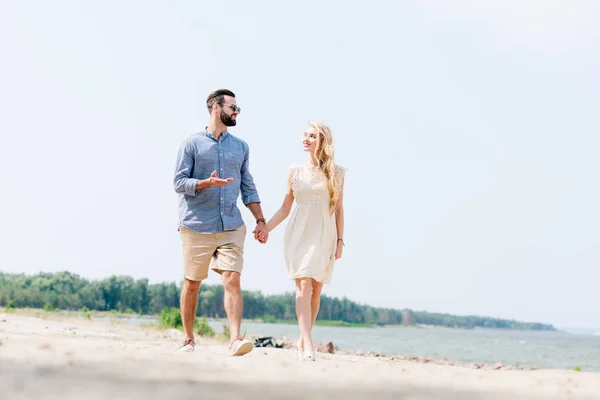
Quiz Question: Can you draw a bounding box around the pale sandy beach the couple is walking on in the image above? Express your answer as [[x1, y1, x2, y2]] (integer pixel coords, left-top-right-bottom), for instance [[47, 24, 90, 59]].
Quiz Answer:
[[0, 312, 600, 400]]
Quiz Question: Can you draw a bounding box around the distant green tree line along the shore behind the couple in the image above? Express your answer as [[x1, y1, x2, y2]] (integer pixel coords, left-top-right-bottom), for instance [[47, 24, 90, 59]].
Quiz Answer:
[[0, 271, 555, 330]]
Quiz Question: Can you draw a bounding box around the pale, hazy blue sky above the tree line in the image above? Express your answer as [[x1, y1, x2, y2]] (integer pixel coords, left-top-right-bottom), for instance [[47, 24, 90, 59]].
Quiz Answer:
[[0, 0, 600, 328]]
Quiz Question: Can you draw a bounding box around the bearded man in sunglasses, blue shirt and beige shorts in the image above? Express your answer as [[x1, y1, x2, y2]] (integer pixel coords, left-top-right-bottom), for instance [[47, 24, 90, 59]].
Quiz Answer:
[[174, 89, 268, 356]]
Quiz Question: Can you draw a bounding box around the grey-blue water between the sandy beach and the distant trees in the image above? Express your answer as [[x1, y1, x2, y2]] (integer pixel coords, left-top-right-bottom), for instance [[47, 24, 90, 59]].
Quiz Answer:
[[94, 318, 600, 371]]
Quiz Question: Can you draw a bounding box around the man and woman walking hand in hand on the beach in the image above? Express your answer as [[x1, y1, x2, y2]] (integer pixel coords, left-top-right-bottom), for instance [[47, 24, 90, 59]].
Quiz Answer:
[[173, 89, 345, 361]]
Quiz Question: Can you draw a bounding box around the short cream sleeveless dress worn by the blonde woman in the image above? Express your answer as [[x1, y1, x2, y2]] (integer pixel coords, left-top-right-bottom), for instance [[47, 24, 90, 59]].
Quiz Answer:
[[283, 164, 346, 283]]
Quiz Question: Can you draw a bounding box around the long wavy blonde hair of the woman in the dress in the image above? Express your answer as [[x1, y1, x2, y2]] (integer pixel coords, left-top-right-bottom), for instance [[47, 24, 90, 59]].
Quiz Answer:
[[310, 121, 340, 214]]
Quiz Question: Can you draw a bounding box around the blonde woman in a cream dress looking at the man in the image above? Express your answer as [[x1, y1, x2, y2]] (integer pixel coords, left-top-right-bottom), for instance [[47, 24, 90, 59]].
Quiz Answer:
[[260, 122, 346, 361]]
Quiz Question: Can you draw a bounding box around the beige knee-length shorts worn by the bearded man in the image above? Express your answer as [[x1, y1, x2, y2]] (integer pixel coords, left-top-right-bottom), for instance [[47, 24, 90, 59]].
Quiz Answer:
[[179, 225, 246, 281]]
